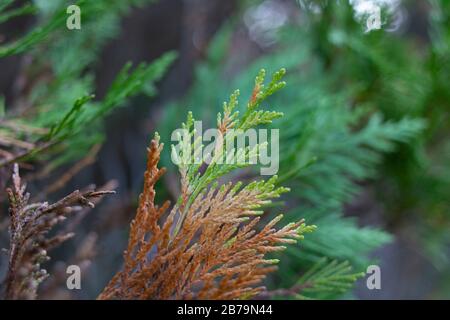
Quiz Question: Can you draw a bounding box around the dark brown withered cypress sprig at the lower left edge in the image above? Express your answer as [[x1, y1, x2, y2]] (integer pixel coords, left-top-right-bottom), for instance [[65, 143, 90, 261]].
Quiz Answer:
[[5, 164, 113, 299]]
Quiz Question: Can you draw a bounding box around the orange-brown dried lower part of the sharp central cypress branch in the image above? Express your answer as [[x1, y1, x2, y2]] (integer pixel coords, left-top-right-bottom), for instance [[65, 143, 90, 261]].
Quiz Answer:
[[99, 138, 314, 299]]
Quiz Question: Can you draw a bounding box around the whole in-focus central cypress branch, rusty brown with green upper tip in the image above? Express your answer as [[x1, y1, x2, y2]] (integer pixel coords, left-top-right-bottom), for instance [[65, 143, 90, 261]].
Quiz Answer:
[[99, 69, 315, 299]]
